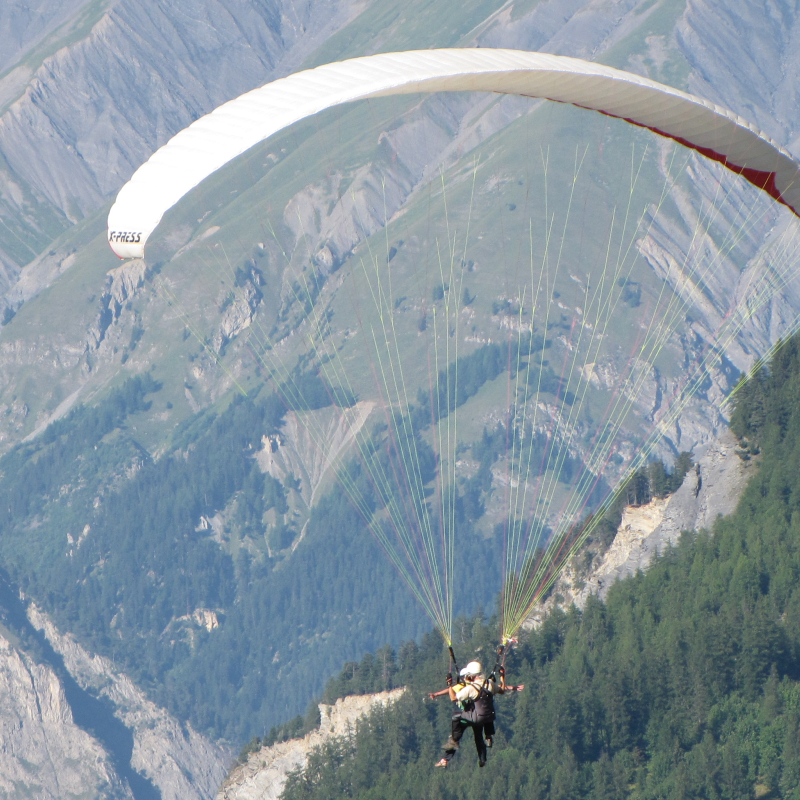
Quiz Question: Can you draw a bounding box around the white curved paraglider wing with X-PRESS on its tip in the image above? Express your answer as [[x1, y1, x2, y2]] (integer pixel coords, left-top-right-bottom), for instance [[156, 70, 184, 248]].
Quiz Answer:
[[108, 48, 800, 258]]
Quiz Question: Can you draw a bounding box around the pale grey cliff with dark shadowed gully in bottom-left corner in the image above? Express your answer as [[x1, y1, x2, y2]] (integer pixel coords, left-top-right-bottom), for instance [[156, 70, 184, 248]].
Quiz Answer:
[[0, 575, 231, 800]]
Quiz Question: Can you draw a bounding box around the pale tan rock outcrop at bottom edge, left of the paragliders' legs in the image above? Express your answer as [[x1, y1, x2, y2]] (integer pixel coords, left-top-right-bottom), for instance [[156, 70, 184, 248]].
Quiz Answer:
[[216, 688, 405, 800]]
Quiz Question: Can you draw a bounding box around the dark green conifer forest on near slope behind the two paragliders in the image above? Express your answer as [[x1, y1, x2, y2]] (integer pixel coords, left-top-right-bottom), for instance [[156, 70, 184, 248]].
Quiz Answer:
[[271, 338, 800, 800]]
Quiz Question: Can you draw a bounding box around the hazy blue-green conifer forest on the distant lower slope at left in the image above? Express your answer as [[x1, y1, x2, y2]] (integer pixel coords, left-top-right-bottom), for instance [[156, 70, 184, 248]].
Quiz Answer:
[[0, 336, 564, 745]]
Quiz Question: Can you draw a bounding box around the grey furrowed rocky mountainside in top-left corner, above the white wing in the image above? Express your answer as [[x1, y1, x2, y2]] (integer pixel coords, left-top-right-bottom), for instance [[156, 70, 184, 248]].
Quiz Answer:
[[0, 0, 362, 288]]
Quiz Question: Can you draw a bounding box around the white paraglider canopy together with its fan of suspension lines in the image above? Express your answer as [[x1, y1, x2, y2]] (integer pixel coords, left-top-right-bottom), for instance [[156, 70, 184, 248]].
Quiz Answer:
[[104, 43, 800, 648]]
